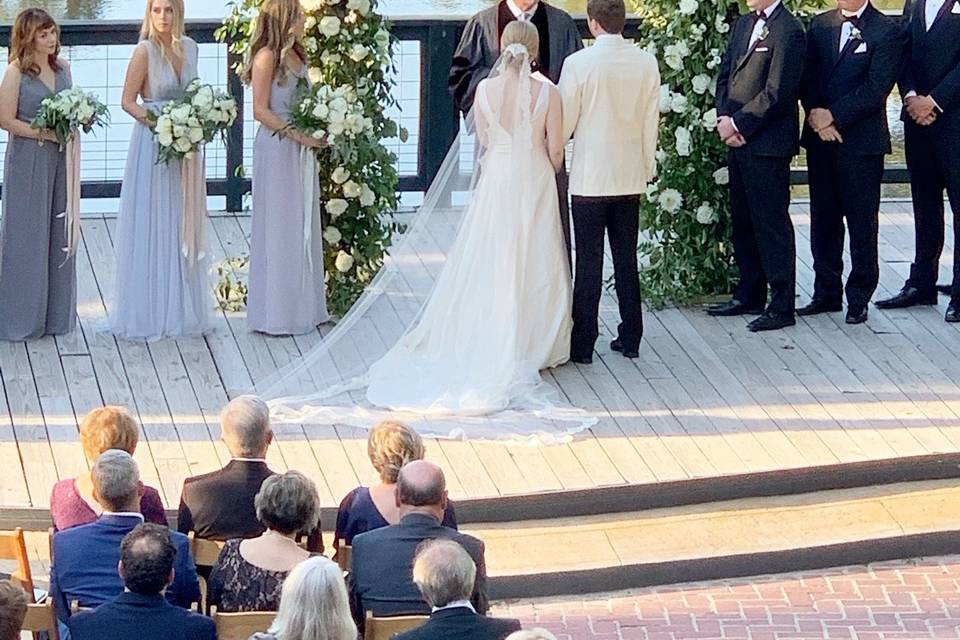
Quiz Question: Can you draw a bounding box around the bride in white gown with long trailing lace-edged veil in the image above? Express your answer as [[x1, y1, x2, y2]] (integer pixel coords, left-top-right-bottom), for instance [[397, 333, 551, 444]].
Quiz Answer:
[[258, 22, 594, 442]]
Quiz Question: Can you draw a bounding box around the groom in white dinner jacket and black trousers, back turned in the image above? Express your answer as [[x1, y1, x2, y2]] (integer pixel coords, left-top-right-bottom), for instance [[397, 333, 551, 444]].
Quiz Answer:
[[560, 0, 660, 364]]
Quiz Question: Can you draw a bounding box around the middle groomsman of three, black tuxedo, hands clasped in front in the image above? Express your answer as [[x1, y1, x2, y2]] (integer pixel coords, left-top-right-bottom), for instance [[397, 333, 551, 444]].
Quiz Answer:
[[797, 0, 903, 324]]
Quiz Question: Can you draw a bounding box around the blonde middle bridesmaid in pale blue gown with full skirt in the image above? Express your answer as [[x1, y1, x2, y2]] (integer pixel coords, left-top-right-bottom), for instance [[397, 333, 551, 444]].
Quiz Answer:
[[110, 0, 212, 340]]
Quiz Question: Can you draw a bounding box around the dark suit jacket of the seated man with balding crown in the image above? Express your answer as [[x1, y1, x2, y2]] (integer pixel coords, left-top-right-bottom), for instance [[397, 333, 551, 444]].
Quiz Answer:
[[350, 514, 487, 624]]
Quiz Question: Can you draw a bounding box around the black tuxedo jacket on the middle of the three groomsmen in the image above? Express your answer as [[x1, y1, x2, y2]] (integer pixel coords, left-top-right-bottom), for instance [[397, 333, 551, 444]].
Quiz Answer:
[[800, 4, 903, 155]]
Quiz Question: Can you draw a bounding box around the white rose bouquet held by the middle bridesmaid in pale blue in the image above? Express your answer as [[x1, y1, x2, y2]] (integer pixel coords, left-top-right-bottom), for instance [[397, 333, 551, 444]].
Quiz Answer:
[[153, 80, 237, 163]]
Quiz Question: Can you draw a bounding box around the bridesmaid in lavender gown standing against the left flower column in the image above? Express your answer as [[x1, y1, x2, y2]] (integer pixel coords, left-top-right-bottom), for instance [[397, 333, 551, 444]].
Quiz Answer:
[[244, 0, 328, 335]]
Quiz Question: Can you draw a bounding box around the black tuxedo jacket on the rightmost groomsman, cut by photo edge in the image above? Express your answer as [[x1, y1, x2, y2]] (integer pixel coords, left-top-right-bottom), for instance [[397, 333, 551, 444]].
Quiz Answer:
[[900, 0, 960, 130]]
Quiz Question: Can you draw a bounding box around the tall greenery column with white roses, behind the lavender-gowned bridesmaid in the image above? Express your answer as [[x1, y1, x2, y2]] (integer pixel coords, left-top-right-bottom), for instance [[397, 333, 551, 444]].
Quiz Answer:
[[217, 0, 406, 316]]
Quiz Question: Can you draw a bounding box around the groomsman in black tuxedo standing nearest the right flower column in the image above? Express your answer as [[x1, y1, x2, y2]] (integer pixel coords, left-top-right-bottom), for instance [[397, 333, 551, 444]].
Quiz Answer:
[[708, 0, 806, 331]]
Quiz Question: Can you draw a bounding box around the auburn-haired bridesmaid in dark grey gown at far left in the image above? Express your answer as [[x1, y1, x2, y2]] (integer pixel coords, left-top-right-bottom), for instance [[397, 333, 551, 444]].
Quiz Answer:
[[0, 9, 77, 340]]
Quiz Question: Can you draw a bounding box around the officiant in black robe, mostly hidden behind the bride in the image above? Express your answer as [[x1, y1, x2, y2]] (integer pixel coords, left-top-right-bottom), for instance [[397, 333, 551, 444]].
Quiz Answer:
[[449, 0, 583, 256]]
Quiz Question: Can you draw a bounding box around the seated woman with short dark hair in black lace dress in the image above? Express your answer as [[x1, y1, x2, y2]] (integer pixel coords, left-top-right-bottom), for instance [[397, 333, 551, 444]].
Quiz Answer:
[[209, 471, 320, 612]]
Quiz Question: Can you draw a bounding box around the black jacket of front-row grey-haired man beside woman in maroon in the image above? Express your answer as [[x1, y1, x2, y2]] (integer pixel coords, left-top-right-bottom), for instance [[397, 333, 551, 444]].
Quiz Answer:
[[177, 460, 323, 553]]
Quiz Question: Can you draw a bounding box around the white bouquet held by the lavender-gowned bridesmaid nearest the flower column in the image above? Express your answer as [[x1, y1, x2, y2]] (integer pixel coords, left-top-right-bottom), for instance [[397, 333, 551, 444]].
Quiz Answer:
[[289, 82, 373, 146]]
